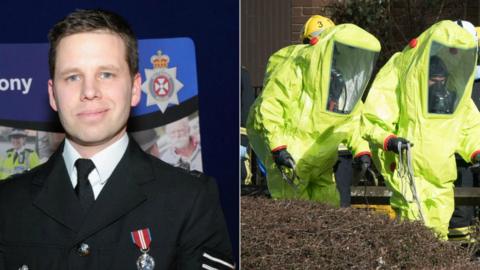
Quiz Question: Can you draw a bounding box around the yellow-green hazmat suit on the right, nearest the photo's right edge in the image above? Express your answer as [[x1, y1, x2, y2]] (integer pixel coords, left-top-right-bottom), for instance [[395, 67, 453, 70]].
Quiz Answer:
[[362, 21, 480, 239]]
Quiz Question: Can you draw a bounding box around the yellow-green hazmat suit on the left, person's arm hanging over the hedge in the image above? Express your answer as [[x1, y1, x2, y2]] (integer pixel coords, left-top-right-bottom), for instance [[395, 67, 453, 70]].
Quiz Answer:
[[247, 24, 380, 205]]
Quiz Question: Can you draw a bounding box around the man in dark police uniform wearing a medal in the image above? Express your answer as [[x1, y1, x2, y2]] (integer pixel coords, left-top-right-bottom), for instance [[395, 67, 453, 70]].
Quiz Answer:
[[0, 10, 234, 270]]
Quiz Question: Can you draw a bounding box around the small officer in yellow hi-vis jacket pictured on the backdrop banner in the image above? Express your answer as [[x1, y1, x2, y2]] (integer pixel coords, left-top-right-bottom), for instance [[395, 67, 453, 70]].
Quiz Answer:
[[0, 128, 40, 179]]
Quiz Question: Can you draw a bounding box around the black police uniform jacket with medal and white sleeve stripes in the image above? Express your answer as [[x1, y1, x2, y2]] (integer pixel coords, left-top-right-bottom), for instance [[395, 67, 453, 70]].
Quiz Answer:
[[0, 139, 233, 270]]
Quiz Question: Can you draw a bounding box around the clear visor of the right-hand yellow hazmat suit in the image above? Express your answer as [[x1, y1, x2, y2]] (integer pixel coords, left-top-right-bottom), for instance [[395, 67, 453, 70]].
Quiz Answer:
[[427, 41, 476, 114]]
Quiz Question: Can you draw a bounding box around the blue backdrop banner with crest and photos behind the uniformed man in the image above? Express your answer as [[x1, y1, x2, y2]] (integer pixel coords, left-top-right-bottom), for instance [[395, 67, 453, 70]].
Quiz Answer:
[[0, 38, 202, 179]]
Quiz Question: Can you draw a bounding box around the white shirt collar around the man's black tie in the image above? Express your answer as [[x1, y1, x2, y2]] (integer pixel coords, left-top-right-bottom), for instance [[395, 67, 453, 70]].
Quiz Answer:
[[62, 133, 129, 199]]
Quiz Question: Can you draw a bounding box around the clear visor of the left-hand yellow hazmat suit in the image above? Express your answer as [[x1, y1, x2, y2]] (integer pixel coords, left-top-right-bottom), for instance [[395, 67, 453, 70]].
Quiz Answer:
[[326, 42, 378, 114]]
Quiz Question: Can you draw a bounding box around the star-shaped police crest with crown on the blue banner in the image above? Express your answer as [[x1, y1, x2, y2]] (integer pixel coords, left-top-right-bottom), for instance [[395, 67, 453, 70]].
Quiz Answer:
[[142, 50, 183, 113]]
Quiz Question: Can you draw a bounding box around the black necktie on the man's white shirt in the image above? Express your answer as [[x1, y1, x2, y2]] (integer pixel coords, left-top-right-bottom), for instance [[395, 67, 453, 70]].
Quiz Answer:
[[75, 158, 95, 211]]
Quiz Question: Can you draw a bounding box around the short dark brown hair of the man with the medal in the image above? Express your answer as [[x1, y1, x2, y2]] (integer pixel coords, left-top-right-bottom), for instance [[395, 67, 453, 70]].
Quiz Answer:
[[48, 9, 138, 79]]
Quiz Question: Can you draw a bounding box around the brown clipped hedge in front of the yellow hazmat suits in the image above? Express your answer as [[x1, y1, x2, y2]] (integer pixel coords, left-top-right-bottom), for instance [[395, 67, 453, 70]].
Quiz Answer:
[[241, 196, 480, 270]]
